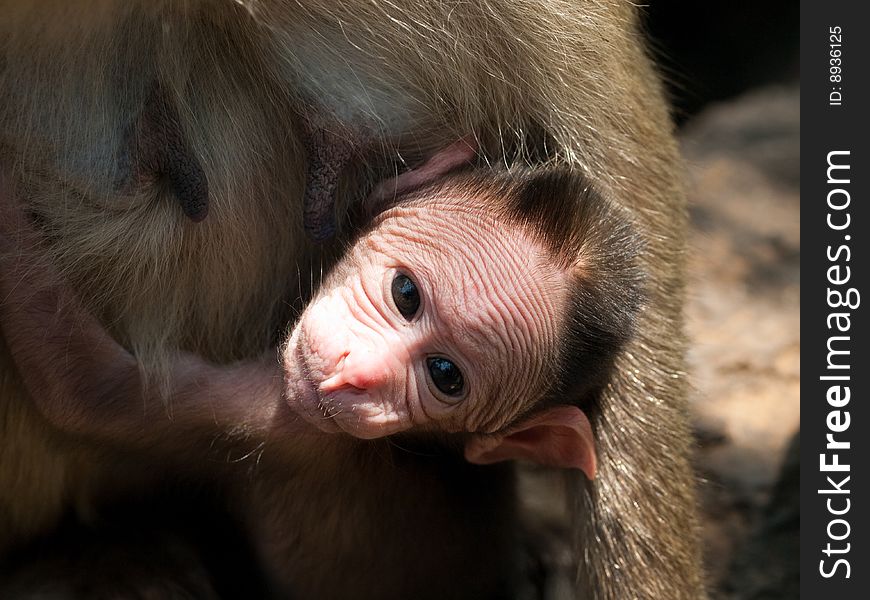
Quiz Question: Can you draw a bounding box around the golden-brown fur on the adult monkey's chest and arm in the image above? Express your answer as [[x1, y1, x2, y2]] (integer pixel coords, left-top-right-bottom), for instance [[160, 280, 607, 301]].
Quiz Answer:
[[0, 0, 703, 600]]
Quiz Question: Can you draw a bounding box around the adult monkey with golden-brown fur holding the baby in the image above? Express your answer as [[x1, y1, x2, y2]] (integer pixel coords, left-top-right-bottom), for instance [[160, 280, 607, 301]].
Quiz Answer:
[[0, 0, 704, 600]]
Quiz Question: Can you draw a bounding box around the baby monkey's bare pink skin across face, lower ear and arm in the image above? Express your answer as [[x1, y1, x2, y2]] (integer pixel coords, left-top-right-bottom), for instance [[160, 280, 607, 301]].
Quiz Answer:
[[0, 147, 595, 478]]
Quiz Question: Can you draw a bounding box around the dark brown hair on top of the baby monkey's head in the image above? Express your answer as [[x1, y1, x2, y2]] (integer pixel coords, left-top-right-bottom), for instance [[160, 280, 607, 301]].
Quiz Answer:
[[505, 169, 644, 418]]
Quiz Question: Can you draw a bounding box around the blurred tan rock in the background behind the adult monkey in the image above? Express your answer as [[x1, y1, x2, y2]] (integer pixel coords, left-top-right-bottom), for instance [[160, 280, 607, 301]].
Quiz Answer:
[[681, 84, 800, 599]]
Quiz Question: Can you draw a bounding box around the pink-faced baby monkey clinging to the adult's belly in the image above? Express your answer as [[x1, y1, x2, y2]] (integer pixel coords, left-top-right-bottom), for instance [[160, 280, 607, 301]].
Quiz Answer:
[[0, 152, 642, 479]]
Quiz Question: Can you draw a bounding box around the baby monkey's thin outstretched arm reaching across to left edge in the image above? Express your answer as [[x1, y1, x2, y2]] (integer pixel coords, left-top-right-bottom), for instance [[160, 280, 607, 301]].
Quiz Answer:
[[0, 173, 308, 446]]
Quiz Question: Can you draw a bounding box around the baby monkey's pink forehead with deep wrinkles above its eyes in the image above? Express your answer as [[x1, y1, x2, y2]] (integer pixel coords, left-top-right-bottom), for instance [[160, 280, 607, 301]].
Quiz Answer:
[[381, 206, 568, 430]]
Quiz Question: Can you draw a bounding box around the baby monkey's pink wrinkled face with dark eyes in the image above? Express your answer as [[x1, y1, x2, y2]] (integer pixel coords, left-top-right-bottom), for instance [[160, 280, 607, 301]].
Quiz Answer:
[[283, 200, 567, 439]]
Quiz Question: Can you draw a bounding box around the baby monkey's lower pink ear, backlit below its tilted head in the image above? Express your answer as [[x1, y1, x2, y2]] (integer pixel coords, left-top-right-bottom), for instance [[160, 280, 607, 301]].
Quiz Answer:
[[465, 406, 596, 479]]
